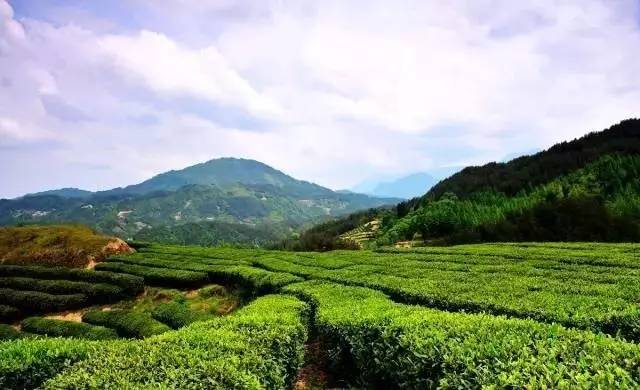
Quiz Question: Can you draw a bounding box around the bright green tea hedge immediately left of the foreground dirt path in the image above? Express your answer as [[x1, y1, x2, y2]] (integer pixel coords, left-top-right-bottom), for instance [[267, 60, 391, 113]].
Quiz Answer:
[[47, 296, 307, 389]]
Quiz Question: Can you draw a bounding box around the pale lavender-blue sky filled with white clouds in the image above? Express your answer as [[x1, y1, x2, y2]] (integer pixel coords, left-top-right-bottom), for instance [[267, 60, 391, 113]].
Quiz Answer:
[[0, 0, 640, 198]]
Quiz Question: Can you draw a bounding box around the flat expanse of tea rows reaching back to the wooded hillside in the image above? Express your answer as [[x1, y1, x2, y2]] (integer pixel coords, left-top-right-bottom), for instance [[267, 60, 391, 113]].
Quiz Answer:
[[128, 244, 640, 340]]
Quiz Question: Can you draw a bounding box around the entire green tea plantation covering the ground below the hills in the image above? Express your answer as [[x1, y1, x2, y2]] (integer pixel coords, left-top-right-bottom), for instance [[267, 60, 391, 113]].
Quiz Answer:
[[0, 243, 640, 389]]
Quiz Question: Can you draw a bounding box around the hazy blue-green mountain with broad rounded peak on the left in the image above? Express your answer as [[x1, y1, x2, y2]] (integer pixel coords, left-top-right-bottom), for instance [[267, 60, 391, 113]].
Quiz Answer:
[[0, 158, 399, 245]]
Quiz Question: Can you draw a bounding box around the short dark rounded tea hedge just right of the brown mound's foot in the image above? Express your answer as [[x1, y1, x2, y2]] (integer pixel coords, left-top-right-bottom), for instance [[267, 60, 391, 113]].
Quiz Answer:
[[96, 262, 209, 287]]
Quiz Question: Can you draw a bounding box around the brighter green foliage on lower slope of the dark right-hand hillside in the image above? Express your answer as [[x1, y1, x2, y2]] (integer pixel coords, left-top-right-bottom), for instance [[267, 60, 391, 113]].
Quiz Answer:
[[378, 155, 640, 245]]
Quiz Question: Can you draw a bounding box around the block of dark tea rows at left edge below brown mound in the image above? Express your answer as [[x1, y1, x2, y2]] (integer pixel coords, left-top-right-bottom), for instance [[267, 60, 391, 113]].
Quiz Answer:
[[0, 265, 144, 323]]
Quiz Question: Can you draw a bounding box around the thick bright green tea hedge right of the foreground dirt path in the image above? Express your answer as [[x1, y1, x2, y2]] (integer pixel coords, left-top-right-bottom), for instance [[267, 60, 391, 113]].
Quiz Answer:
[[285, 282, 640, 389]]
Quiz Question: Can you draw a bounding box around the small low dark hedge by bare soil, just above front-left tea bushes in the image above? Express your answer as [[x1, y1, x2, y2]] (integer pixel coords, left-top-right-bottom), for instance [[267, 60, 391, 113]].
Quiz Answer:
[[21, 317, 118, 340]]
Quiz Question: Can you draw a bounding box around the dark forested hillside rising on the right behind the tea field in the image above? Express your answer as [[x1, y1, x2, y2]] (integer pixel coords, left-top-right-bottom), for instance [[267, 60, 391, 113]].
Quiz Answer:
[[293, 119, 640, 249]]
